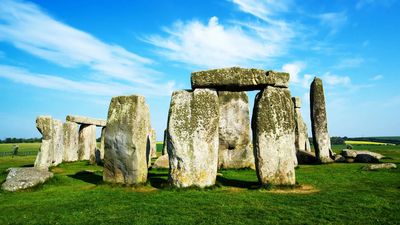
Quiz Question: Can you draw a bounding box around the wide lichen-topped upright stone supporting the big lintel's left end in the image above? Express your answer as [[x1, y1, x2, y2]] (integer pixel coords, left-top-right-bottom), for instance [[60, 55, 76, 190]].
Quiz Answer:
[[167, 89, 219, 187]]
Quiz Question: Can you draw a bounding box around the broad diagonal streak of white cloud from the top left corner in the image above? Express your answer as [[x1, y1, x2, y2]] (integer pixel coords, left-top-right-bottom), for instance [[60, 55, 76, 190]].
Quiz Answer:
[[0, 0, 175, 94]]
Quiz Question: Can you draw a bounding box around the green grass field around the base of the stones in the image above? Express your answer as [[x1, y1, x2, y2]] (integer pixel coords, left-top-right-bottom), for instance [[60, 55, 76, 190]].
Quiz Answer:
[[0, 145, 400, 224]]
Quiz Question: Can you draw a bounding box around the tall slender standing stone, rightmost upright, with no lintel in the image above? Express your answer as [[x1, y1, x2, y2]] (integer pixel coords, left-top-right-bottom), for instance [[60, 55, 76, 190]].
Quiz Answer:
[[310, 77, 333, 163]]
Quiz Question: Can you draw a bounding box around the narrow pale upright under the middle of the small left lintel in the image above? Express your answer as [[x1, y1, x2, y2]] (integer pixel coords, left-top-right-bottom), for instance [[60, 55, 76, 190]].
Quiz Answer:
[[78, 124, 97, 163]]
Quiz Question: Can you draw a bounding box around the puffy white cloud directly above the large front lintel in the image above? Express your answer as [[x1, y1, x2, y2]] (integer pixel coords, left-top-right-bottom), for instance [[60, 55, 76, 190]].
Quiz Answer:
[[145, 17, 290, 68]]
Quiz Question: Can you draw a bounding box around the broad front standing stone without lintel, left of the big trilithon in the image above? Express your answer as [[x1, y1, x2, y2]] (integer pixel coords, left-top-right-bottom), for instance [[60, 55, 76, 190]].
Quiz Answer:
[[103, 95, 150, 185]]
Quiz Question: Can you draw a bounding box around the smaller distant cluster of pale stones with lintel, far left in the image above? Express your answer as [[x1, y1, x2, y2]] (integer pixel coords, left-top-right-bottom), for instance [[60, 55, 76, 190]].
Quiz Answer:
[[34, 115, 106, 169]]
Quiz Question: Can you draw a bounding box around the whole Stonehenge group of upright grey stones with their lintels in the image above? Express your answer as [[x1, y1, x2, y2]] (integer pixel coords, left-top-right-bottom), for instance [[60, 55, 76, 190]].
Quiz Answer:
[[35, 67, 334, 188]]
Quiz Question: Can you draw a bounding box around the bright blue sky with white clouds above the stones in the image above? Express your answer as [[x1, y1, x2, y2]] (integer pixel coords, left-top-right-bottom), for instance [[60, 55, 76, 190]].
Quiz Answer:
[[0, 0, 400, 140]]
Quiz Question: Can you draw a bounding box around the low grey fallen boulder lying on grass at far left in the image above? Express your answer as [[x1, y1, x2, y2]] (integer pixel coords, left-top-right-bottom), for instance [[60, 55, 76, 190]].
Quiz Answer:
[[1, 167, 53, 191]]
